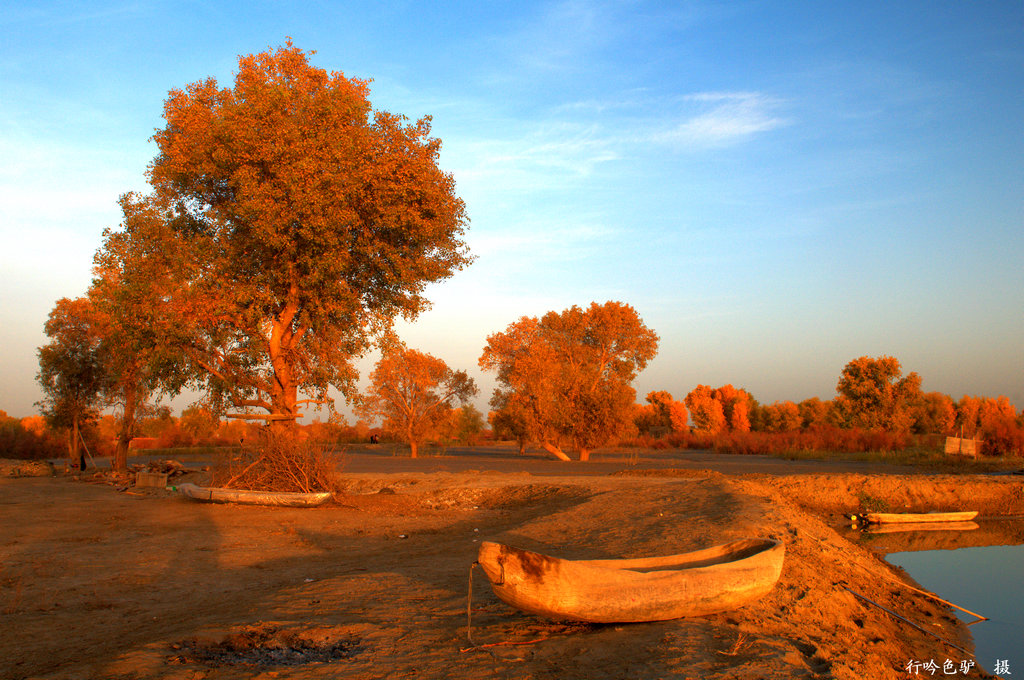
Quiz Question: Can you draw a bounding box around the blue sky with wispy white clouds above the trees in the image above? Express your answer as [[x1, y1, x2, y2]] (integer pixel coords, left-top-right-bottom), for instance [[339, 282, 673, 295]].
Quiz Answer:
[[0, 0, 1024, 417]]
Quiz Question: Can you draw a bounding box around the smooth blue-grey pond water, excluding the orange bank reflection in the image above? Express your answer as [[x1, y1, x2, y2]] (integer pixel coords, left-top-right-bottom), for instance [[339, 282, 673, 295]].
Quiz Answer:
[[886, 545, 1024, 680]]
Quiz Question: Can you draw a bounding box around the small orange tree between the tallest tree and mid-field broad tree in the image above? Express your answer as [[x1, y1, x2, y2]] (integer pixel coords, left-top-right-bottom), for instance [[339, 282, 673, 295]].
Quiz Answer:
[[356, 345, 477, 458]]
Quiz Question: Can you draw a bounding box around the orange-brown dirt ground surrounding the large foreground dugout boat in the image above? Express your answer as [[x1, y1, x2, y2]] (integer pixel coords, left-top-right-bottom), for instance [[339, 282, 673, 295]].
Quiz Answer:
[[0, 456, 1024, 680]]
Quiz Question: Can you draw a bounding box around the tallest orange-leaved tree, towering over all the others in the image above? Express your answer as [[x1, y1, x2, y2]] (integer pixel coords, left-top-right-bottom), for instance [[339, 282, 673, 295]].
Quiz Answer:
[[141, 41, 469, 423]]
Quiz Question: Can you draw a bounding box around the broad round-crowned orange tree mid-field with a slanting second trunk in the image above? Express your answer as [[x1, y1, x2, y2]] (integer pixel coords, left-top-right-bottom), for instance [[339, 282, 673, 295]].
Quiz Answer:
[[479, 301, 658, 461]]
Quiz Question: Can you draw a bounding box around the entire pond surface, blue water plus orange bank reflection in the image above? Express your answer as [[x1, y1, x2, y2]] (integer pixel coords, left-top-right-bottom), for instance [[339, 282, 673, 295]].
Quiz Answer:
[[880, 521, 1024, 677]]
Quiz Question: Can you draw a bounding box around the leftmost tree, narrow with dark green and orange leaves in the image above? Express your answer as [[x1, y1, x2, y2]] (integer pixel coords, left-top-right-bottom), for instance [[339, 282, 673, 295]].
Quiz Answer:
[[36, 298, 108, 468]]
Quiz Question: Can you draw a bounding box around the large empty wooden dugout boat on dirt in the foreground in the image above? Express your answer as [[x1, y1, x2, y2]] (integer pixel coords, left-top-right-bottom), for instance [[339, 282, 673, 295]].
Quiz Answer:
[[478, 539, 784, 623]]
